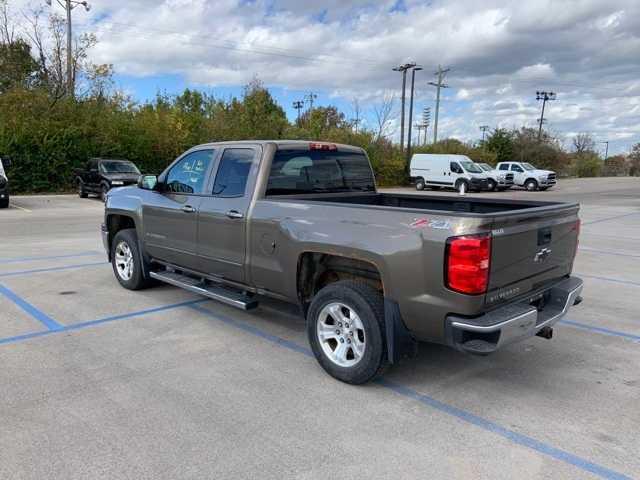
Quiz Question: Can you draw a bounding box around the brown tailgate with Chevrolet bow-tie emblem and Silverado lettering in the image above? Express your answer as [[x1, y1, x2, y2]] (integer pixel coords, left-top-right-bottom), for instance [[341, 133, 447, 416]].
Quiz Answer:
[[486, 205, 580, 304]]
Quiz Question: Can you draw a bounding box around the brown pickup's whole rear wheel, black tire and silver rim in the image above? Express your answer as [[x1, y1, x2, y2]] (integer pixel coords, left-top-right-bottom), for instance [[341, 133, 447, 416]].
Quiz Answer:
[[307, 280, 388, 385]]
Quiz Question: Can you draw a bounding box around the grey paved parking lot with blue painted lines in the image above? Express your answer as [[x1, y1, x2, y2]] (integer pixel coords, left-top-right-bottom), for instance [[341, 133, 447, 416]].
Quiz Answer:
[[0, 178, 640, 479]]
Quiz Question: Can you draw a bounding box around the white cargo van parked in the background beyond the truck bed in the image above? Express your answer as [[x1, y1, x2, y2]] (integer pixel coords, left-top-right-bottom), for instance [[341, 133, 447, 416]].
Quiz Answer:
[[409, 153, 488, 191]]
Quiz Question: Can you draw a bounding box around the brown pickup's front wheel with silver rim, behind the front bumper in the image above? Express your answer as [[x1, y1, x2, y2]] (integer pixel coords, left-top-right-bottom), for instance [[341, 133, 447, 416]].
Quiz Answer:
[[111, 228, 151, 290]]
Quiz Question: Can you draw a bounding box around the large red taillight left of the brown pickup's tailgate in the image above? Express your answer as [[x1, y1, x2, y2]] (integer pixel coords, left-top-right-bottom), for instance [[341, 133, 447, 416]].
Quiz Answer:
[[445, 234, 491, 295]]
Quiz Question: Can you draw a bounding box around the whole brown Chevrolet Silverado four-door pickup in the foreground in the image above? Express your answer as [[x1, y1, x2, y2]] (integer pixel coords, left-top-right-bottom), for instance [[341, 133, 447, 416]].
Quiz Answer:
[[102, 140, 582, 384]]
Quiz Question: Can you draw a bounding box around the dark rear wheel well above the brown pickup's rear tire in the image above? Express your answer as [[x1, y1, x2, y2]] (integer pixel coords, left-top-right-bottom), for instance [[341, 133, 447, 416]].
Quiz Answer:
[[297, 252, 384, 315]]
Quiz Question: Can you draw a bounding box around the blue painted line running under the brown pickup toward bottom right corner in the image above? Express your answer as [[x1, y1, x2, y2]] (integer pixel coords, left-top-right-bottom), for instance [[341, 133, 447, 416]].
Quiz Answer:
[[189, 306, 631, 480]]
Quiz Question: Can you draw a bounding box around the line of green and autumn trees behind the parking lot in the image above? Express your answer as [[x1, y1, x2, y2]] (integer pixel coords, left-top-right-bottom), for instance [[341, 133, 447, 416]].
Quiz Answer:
[[0, 0, 640, 193]]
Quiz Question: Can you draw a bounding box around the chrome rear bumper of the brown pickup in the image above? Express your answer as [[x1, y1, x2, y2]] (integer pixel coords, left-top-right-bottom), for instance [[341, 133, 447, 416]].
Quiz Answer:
[[446, 277, 582, 355]]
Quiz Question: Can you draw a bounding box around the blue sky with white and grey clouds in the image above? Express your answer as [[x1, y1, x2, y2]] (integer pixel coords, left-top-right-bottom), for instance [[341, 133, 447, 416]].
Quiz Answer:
[[13, 0, 640, 155]]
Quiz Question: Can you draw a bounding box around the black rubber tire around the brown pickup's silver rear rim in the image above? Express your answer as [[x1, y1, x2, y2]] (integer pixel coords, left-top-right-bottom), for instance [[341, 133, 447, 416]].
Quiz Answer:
[[307, 280, 388, 385]]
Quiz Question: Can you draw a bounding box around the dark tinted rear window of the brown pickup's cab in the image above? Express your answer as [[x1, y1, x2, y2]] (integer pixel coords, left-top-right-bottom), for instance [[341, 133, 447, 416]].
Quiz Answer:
[[266, 149, 375, 195]]
